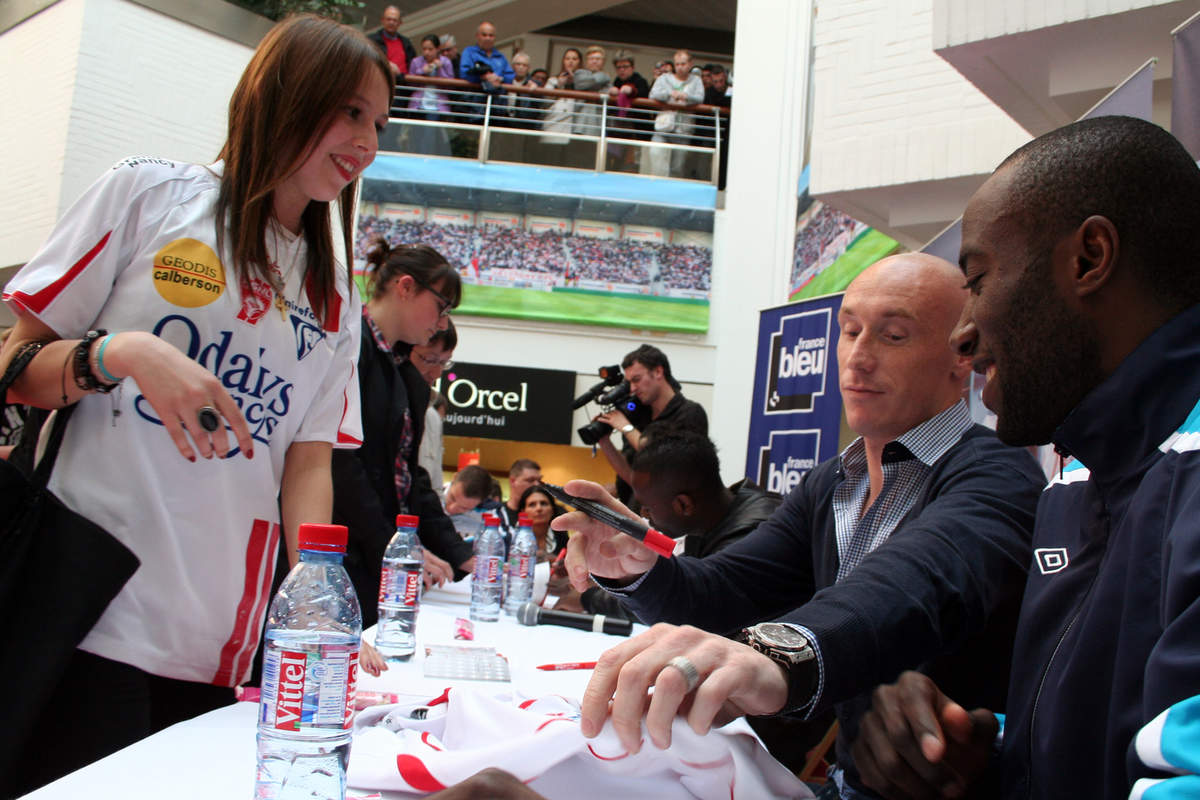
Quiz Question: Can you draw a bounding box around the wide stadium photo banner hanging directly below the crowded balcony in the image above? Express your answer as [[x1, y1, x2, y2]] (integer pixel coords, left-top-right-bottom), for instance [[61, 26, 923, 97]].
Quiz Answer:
[[354, 154, 716, 333]]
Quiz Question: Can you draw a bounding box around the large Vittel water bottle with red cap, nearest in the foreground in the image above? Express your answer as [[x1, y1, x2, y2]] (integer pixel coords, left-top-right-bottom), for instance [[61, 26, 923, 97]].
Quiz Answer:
[[254, 524, 362, 800]]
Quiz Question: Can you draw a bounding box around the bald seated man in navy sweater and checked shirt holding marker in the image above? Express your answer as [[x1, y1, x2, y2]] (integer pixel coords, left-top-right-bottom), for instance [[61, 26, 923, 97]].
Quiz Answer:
[[552, 253, 1045, 799]]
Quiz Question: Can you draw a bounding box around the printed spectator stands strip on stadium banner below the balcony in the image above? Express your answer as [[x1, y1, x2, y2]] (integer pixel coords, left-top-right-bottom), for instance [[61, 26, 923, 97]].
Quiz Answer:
[[355, 215, 713, 291]]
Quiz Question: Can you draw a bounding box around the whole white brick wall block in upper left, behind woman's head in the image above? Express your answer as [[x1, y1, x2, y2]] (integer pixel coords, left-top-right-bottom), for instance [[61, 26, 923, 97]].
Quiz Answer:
[[0, 0, 251, 266]]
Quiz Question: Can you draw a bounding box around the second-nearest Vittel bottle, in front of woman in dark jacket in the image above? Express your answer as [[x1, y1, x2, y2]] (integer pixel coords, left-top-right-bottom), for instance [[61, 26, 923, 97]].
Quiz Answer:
[[376, 513, 425, 661]]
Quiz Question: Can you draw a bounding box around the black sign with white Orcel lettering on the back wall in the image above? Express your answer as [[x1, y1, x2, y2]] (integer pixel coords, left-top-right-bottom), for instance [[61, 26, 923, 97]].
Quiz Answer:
[[433, 361, 575, 445]]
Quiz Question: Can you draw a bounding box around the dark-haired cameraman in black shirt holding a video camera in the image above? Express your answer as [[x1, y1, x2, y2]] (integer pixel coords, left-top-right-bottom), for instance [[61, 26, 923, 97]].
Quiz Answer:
[[594, 344, 708, 503]]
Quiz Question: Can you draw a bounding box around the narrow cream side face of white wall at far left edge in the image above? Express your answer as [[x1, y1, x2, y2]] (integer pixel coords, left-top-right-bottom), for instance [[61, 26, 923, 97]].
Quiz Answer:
[[0, 0, 85, 266]]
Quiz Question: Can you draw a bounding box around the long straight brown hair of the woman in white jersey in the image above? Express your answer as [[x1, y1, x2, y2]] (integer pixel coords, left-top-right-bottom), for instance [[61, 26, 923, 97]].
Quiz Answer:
[[216, 14, 395, 326]]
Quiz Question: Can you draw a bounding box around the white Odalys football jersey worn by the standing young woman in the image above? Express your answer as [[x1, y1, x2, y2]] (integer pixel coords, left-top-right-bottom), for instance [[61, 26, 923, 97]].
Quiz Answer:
[[5, 158, 362, 686]]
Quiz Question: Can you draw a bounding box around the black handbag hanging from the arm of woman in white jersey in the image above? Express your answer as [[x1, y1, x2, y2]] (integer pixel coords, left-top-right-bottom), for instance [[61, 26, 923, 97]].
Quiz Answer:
[[0, 345, 139, 796]]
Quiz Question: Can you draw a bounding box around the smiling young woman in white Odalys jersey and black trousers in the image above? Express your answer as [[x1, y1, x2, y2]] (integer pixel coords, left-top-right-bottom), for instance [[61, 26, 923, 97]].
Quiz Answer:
[[0, 17, 394, 793]]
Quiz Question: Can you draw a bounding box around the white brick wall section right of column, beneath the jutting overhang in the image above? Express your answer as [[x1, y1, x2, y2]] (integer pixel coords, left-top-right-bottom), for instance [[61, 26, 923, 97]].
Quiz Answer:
[[806, 0, 1030, 194]]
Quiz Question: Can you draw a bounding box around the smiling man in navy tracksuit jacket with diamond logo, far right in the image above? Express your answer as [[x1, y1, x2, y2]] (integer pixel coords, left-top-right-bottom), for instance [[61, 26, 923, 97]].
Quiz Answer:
[[856, 116, 1200, 800]]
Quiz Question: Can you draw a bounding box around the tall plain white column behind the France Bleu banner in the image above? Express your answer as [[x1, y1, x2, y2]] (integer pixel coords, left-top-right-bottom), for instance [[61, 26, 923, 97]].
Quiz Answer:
[[709, 0, 812, 482]]
